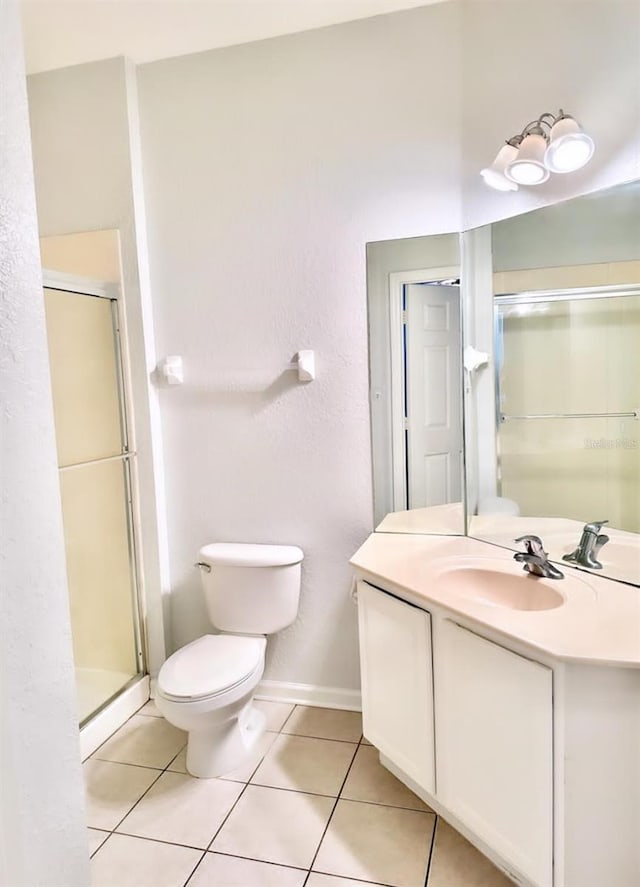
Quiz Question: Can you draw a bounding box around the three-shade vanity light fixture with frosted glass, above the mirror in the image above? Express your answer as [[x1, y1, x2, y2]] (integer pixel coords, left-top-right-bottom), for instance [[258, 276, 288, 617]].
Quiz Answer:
[[480, 109, 595, 191]]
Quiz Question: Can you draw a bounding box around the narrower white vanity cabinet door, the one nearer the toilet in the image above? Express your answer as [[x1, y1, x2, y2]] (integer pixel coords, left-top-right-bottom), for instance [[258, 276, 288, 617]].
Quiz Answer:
[[358, 582, 434, 793]]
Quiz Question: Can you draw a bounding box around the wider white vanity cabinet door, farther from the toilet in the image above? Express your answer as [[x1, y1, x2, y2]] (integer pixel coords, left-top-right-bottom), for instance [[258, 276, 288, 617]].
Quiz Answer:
[[435, 621, 553, 887]]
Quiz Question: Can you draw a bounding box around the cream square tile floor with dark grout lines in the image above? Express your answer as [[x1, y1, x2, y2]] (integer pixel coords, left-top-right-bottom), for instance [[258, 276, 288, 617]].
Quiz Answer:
[[84, 702, 510, 887]]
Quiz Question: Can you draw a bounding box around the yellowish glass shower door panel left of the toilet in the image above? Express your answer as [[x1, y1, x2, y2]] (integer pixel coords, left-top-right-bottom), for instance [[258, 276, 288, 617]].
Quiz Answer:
[[44, 288, 144, 725]]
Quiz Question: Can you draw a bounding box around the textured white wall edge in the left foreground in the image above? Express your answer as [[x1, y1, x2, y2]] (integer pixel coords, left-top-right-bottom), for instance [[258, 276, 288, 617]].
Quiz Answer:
[[0, 2, 89, 887]]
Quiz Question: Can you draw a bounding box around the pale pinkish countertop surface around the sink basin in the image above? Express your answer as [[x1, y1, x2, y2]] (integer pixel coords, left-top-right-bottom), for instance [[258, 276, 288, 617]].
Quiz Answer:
[[350, 533, 640, 667]]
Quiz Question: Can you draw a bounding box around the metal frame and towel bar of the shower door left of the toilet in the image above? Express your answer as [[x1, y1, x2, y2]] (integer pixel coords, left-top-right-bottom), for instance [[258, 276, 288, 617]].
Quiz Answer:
[[42, 269, 149, 728]]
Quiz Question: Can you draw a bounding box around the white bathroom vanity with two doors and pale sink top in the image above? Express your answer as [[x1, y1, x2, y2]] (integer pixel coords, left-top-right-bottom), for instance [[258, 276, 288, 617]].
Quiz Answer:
[[351, 533, 640, 887]]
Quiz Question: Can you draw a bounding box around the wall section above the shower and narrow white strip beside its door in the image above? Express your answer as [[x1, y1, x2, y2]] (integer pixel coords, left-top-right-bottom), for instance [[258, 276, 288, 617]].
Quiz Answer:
[[28, 59, 169, 674]]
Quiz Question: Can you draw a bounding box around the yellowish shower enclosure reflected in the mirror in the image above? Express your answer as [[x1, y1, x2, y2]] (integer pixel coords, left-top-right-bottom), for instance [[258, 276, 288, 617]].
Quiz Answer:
[[495, 285, 640, 533]]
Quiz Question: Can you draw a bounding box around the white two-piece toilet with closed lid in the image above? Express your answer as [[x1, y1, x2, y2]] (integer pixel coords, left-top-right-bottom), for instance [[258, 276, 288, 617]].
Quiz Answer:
[[155, 542, 304, 777]]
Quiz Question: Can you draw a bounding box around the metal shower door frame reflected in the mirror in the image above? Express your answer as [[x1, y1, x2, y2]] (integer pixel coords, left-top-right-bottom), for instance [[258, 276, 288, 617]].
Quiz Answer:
[[493, 283, 640, 496]]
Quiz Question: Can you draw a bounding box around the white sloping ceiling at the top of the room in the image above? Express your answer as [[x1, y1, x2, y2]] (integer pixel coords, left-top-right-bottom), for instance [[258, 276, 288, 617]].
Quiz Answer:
[[22, 0, 446, 74]]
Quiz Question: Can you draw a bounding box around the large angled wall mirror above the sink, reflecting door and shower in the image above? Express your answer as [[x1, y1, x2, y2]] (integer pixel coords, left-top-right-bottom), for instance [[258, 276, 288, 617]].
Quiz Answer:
[[367, 182, 640, 585]]
